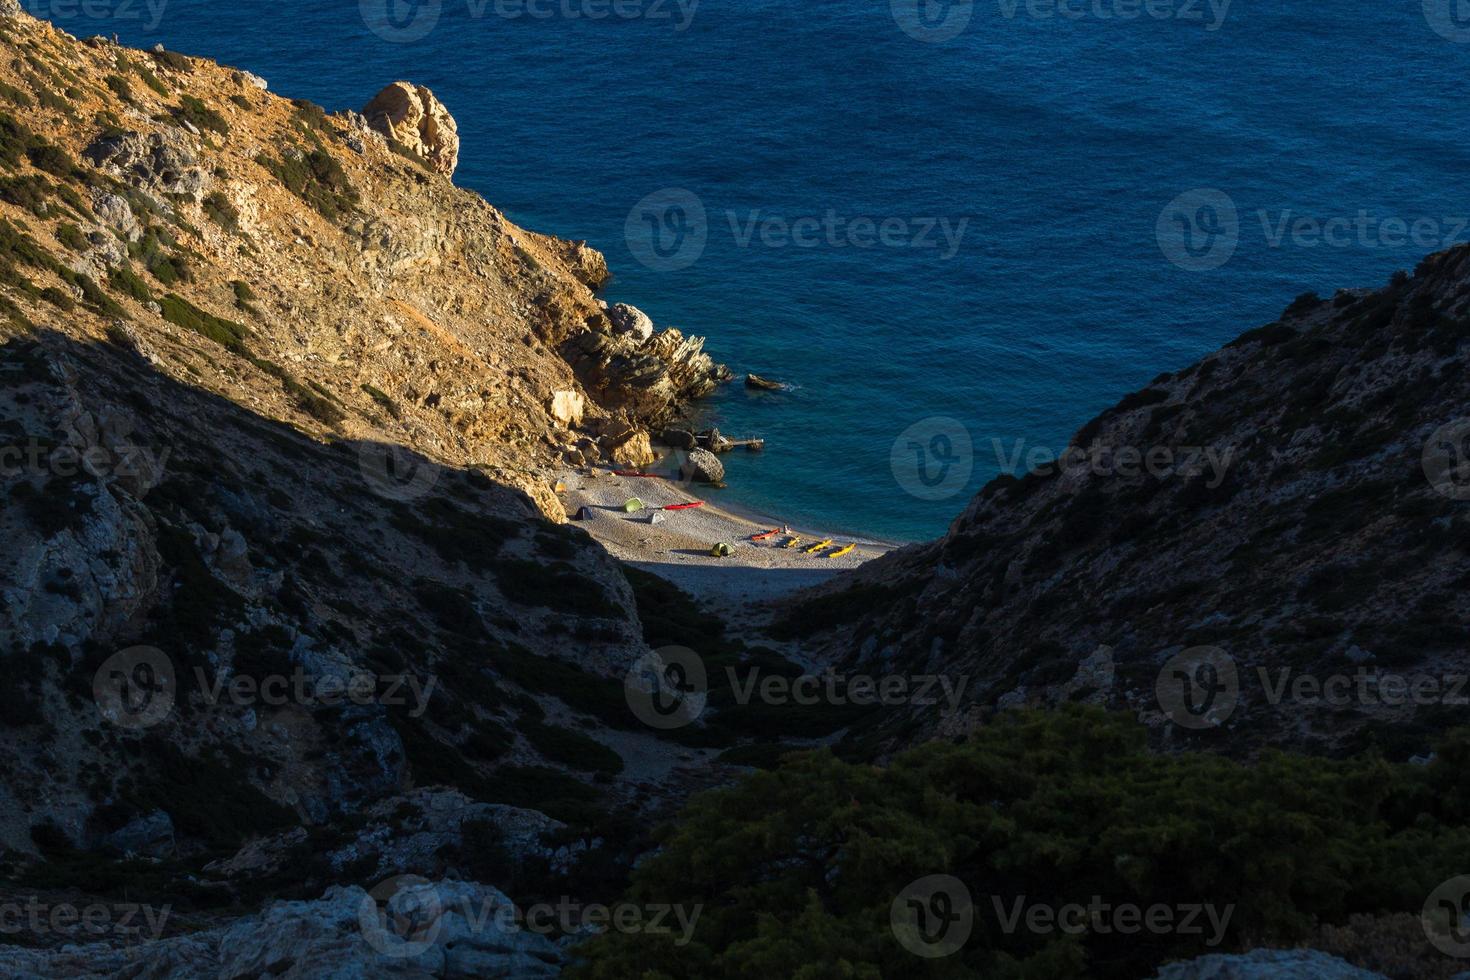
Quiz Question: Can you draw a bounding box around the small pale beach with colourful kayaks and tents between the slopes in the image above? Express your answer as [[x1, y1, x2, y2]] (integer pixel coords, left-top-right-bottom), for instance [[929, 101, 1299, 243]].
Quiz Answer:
[[560, 467, 898, 605]]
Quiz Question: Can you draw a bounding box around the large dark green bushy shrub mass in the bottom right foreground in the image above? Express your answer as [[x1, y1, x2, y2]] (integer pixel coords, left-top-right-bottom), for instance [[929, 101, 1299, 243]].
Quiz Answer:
[[569, 705, 1470, 980]]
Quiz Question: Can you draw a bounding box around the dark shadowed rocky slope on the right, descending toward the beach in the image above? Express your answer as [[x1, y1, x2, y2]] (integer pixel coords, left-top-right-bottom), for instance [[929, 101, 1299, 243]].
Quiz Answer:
[[782, 247, 1470, 758]]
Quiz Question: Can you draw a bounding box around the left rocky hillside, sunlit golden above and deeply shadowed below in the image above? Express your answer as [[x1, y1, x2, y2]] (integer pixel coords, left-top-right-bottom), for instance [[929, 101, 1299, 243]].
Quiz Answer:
[[0, 10, 728, 976]]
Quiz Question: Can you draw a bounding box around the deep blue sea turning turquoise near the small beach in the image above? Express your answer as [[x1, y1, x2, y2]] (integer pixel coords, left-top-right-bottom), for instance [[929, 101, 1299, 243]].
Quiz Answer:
[[63, 0, 1470, 538]]
